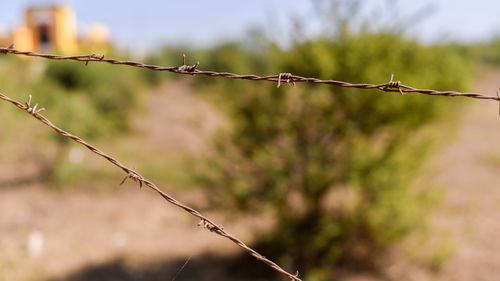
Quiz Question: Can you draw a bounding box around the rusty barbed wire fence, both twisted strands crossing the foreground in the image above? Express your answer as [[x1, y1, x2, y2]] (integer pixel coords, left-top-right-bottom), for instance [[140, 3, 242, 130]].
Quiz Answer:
[[0, 44, 494, 281]]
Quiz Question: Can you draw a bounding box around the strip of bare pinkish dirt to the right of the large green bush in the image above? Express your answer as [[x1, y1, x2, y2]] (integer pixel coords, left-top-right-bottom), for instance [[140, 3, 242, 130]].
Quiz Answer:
[[426, 66, 500, 280]]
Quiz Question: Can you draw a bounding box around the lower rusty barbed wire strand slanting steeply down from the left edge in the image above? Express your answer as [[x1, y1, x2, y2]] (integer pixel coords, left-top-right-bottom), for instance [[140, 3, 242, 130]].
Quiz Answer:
[[0, 93, 302, 281]]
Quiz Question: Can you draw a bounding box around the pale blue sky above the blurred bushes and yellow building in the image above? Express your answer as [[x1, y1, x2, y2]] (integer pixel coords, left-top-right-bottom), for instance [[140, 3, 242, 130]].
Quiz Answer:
[[0, 0, 500, 49]]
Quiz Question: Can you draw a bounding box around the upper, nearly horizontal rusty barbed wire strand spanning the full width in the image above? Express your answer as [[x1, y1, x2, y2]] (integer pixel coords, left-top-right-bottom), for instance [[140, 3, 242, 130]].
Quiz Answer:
[[0, 47, 500, 101]]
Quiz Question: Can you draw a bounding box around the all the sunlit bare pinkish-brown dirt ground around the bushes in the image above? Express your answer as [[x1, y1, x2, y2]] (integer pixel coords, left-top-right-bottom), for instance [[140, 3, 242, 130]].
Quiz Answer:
[[0, 69, 500, 281]]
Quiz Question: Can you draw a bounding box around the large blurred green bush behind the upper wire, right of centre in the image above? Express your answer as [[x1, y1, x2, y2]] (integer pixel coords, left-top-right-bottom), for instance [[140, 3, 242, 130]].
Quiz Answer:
[[193, 31, 472, 276]]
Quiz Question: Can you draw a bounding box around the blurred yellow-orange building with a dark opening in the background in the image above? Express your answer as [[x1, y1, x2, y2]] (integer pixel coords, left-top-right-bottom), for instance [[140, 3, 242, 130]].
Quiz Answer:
[[0, 6, 108, 53]]
